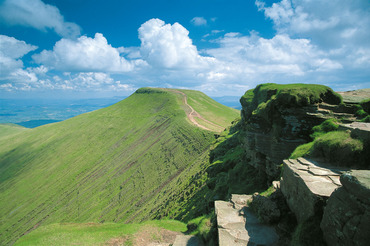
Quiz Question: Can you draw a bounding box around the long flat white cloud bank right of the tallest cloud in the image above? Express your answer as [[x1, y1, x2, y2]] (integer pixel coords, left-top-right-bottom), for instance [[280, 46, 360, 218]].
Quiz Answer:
[[207, 33, 342, 76]]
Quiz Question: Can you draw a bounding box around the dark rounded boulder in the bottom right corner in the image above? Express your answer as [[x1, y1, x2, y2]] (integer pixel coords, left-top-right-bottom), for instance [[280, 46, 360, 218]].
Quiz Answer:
[[321, 170, 370, 246]]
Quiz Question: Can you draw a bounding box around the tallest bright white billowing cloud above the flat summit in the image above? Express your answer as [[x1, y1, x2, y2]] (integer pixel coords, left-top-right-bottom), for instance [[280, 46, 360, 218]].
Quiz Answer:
[[139, 19, 212, 69]]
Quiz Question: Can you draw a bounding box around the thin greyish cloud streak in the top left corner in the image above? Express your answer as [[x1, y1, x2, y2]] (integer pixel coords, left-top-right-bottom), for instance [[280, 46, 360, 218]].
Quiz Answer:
[[0, 0, 80, 37]]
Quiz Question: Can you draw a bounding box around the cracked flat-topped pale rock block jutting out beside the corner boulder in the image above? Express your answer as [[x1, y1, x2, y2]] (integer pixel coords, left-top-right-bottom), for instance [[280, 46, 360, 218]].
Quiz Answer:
[[281, 158, 343, 222]]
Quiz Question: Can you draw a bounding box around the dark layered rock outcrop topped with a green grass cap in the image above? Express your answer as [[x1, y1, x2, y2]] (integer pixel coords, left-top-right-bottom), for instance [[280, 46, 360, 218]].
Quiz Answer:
[[240, 84, 355, 182]]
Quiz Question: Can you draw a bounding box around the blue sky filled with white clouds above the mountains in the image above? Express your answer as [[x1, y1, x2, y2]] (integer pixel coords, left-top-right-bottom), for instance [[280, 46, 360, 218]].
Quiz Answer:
[[0, 0, 370, 98]]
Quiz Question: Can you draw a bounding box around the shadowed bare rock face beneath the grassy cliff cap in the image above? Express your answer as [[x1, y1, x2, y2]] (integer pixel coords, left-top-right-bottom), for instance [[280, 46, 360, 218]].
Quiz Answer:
[[242, 104, 356, 181]]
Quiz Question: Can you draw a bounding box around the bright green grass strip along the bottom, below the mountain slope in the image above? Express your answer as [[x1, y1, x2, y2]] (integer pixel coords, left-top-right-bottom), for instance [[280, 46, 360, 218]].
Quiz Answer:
[[15, 220, 187, 246]]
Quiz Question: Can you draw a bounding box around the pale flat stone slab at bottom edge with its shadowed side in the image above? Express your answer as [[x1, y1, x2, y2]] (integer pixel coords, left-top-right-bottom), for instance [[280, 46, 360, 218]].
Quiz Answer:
[[215, 199, 279, 246]]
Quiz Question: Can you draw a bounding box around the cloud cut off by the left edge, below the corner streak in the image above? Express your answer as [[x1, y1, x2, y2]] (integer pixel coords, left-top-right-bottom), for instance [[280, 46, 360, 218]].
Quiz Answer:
[[0, 35, 37, 83]]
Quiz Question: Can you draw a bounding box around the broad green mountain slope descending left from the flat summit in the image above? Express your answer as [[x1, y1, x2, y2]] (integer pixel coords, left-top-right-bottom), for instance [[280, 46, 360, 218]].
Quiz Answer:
[[0, 88, 238, 244]]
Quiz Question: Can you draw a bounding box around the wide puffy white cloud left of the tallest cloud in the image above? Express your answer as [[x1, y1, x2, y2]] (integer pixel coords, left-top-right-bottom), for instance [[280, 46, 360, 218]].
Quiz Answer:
[[33, 33, 134, 73]]
